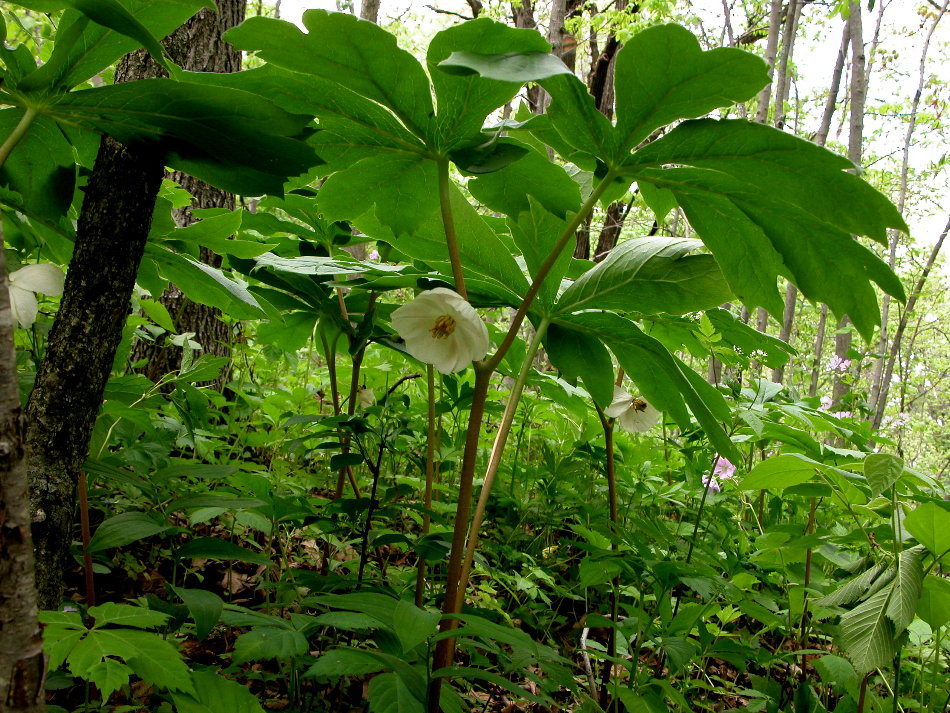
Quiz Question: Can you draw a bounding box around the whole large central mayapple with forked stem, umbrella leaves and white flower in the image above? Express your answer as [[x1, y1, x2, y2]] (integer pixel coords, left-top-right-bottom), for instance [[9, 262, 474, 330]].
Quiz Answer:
[[219, 10, 906, 711]]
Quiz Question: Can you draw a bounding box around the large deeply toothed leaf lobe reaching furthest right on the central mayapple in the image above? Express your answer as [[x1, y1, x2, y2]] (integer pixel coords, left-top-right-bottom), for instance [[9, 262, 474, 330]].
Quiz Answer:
[[624, 120, 905, 337]]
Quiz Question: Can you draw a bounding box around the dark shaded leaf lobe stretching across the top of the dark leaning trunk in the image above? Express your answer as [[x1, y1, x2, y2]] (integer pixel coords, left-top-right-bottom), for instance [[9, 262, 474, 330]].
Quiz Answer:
[[42, 79, 319, 195]]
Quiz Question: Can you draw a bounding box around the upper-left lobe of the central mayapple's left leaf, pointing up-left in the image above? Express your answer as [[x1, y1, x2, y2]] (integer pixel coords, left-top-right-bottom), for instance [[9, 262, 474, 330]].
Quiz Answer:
[[225, 10, 433, 136]]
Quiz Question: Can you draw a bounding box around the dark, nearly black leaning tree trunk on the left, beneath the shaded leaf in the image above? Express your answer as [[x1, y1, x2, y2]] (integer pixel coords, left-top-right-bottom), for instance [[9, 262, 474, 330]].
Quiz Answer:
[[27, 47, 163, 609]]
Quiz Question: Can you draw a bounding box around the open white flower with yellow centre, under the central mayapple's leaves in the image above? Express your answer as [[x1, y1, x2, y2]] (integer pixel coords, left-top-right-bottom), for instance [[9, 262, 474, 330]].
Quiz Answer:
[[392, 287, 490, 374]]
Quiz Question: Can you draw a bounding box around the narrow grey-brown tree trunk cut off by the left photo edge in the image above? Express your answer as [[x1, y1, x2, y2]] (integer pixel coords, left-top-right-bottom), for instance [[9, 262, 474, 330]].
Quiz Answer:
[[0, 228, 46, 713]]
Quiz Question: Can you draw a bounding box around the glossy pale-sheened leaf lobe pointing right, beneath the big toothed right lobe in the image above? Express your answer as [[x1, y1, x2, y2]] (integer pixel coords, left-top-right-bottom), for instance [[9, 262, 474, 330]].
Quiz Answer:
[[555, 236, 732, 315]]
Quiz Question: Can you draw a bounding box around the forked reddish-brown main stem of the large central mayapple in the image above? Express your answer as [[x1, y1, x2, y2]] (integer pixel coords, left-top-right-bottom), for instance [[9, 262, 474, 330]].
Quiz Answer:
[[427, 172, 617, 713]]
